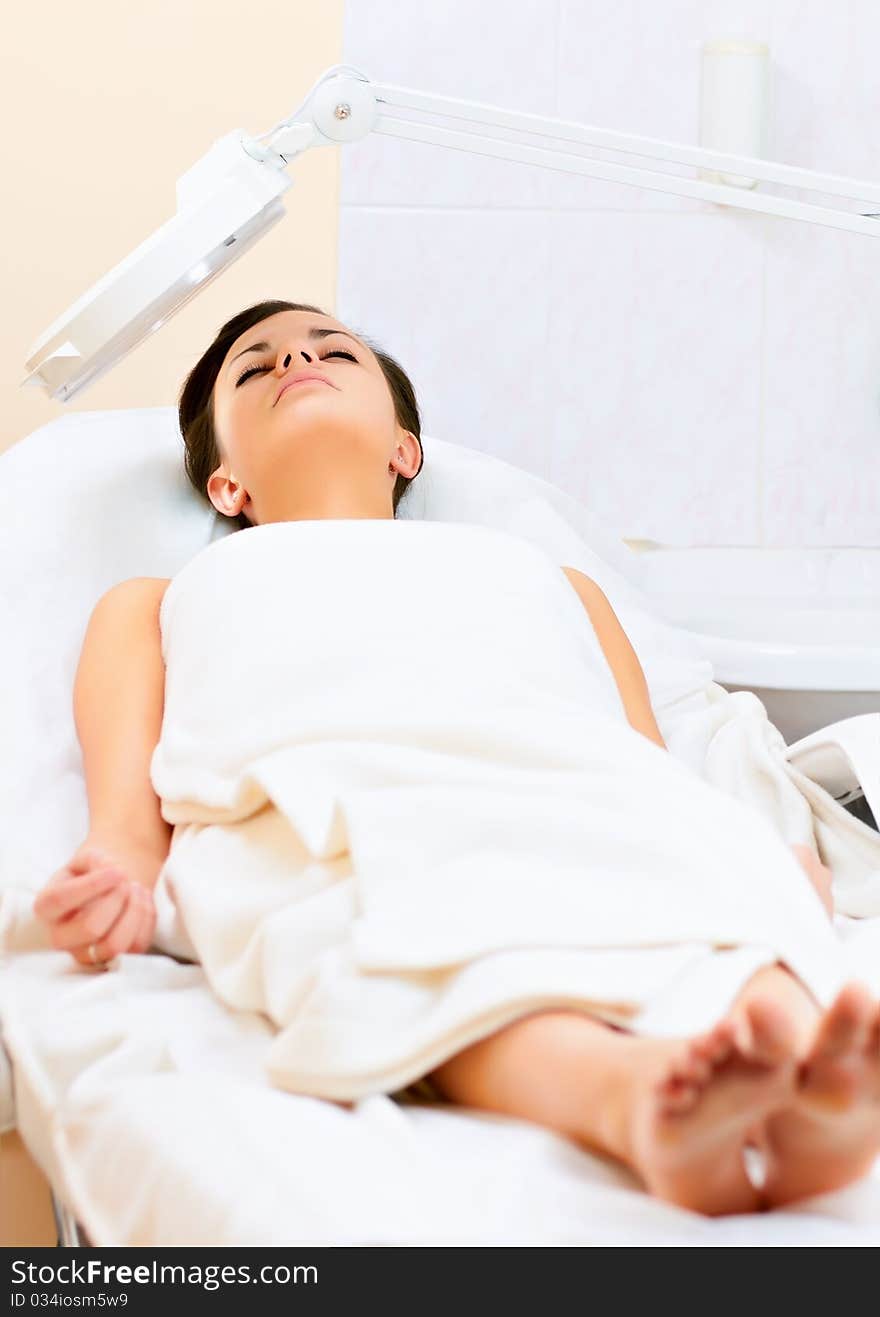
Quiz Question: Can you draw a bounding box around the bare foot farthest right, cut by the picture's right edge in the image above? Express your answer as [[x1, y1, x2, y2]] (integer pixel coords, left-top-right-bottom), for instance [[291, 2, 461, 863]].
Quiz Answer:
[[765, 984, 880, 1206]]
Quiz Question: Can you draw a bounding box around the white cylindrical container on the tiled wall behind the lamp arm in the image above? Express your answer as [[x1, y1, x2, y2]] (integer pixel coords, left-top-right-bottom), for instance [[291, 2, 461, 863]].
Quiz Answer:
[[697, 41, 769, 188]]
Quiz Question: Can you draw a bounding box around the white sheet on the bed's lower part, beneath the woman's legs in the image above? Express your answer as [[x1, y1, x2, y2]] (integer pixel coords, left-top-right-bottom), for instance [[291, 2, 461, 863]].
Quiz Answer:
[[0, 919, 880, 1246]]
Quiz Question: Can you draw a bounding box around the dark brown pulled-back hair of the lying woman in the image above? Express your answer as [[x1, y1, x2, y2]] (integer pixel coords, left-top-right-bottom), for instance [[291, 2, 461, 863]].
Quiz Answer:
[[178, 302, 424, 531]]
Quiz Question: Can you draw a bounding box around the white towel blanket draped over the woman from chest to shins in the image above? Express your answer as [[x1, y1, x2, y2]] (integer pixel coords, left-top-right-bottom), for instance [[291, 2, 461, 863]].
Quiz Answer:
[[151, 519, 844, 1101]]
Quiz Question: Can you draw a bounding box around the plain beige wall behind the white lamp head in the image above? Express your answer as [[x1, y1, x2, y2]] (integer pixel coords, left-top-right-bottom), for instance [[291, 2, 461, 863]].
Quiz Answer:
[[0, 0, 344, 449]]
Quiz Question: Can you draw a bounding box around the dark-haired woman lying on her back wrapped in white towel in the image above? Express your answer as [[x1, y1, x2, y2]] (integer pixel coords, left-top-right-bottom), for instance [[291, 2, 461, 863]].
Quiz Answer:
[[36, 302, 880, 1214]]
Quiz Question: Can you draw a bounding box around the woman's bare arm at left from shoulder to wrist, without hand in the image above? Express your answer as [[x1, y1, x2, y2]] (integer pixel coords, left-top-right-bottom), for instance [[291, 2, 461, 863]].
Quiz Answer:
[[74, 577, 174, 856]]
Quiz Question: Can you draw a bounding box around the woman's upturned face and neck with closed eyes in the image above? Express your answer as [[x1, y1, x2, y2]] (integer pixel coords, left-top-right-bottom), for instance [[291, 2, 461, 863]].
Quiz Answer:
[[207, 311, 420, 525]]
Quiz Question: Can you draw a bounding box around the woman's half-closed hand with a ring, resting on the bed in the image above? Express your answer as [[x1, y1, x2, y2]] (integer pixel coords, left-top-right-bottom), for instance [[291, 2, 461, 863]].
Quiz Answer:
[[34, 832, 166, 965]]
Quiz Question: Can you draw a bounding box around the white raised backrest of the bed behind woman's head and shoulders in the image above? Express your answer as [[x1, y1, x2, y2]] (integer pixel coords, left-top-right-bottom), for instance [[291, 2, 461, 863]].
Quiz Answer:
[[0, 407, 711, 890]]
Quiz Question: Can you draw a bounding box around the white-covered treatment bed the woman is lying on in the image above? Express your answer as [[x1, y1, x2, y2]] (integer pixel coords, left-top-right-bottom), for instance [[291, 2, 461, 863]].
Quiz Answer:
[[0, 408, 880, 1246]]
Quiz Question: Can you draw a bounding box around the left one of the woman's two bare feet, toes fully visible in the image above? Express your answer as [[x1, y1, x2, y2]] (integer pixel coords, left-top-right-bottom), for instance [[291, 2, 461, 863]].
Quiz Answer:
[[632, 998, 797, 1216]]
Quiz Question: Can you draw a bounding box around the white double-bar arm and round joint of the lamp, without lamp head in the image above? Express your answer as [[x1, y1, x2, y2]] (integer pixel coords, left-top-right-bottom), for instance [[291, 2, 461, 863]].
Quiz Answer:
[[258, 66, 880, 237]]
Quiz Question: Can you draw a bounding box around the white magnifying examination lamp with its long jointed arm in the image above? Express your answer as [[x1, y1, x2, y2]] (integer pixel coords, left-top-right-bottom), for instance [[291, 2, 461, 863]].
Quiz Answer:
[[21, 65, 880, 403]]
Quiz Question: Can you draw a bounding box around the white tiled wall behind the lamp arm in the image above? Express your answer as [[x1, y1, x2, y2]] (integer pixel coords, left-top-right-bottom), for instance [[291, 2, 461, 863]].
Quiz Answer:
[[335, 0, 880, 547]]
